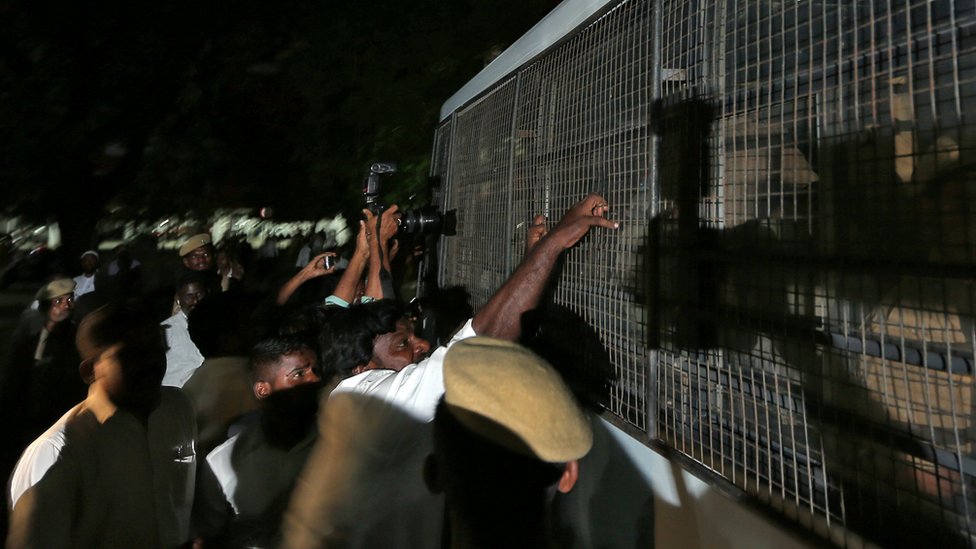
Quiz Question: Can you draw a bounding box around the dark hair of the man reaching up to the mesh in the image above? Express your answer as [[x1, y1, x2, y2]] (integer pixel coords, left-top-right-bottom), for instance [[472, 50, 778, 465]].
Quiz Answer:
[[319, 299, 404, 378]]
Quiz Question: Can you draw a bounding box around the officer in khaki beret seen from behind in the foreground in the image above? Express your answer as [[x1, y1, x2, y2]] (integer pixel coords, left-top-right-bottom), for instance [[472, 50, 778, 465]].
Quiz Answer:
[[424, 337, 593, 548]]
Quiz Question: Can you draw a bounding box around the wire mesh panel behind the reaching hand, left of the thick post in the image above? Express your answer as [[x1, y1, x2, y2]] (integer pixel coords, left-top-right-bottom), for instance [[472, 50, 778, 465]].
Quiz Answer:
[[512, 5, 651, 429]]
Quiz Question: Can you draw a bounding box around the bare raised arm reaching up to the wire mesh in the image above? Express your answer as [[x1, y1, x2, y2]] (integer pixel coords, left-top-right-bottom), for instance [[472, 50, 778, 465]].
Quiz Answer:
[[472, 194, 619, 341]]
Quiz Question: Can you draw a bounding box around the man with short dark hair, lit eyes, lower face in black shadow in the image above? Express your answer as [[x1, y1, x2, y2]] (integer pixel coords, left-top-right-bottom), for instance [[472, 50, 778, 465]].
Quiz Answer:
[[194, 336, 322, 547]]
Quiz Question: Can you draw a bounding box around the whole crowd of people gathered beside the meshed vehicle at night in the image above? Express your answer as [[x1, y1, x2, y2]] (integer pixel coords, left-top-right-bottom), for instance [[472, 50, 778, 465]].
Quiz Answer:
[[0, 194, 617, 548]]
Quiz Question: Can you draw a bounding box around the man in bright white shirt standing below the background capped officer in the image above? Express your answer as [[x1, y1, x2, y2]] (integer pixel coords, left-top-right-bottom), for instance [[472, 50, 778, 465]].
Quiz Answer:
[[161, 271, 208, 387]]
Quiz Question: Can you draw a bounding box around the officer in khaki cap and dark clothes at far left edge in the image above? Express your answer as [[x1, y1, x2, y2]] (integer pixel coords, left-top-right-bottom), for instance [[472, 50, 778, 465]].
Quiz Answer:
[[0, 278, 86, 450]]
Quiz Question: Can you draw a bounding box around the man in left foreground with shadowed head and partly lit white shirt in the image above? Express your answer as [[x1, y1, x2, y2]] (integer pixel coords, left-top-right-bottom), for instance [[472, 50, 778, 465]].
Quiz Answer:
[[7, 306, 196, 548]]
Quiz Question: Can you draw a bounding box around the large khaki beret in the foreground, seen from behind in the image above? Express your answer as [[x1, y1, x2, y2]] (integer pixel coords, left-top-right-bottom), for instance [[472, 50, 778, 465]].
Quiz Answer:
[[444, 337, 593, 463]]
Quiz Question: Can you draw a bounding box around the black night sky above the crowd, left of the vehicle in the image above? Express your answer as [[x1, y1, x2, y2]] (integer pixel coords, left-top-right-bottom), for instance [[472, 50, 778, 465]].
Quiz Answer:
[[0, 0, 558, 254]]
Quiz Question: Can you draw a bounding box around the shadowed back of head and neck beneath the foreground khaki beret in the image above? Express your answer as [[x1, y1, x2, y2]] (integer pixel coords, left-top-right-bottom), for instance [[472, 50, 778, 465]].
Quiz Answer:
[[434, 398, 562, 547]]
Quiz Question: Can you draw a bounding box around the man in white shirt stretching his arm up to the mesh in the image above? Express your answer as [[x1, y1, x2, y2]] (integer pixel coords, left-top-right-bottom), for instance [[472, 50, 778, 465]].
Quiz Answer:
[[283, 194, 618, 547]]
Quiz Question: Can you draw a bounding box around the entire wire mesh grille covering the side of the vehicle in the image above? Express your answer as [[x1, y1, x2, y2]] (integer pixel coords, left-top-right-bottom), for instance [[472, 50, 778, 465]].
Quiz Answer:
[[437, 0, 976, 546]]
